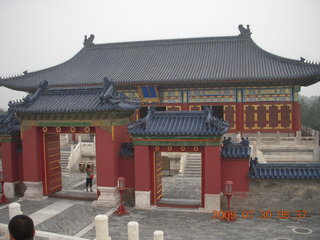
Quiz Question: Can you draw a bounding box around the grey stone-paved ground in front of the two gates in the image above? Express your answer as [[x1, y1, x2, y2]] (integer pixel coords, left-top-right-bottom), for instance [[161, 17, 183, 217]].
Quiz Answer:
[[0, 198, 320, 240]]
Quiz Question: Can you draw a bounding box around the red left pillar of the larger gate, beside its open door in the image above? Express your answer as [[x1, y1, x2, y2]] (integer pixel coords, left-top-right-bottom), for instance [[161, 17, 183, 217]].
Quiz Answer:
[[22, 127, 44, 182]]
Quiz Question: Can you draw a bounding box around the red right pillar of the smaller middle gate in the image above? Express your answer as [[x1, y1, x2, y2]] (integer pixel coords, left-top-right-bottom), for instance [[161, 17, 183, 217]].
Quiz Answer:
[[204, 146, 221, 194]]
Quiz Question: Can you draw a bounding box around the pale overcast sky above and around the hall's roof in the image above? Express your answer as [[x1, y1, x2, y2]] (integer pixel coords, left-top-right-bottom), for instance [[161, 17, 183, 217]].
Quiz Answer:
[[0, 0, 320, 108]]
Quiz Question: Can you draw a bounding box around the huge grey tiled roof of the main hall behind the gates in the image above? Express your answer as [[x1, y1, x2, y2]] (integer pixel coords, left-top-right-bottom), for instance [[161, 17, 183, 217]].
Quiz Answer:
[[0, 25, 320, 91]]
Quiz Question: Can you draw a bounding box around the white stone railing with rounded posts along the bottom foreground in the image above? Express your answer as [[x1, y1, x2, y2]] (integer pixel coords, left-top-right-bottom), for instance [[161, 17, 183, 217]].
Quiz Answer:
[[0, 203, 164, 240]]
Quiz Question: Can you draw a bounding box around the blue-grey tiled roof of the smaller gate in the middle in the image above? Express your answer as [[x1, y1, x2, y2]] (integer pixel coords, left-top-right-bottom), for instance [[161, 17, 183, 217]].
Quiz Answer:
[[128, 109, 229, 136]]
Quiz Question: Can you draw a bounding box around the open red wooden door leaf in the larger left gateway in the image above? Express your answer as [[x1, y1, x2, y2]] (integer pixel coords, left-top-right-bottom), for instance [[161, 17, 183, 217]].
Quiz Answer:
[[44, 134, 62, 195]]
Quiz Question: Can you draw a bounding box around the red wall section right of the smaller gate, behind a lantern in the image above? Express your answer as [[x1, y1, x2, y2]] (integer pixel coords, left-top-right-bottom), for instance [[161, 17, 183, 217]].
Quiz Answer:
[[220, 158, 249, 192]]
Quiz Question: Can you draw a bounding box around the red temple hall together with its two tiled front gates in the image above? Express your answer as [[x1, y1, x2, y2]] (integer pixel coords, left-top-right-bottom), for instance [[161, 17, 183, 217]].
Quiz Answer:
[[0, 25, 320, 211]]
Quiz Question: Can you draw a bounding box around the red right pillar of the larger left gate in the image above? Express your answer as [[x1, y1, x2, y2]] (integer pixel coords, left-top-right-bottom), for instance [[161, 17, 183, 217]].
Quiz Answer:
[[96, 127, 118, 187]]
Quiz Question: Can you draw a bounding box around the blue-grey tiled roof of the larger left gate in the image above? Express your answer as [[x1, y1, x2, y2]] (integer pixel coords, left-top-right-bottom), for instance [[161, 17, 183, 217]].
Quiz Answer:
[[9, 80, 139, 113]]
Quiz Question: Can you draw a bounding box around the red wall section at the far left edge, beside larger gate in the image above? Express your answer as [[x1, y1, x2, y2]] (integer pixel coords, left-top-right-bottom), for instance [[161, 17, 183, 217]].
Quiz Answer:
[[1, 142, 19, 183]]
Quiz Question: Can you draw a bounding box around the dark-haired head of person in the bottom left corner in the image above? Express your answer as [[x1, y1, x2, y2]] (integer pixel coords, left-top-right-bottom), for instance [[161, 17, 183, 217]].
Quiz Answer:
[[8, 215, 35, 240]]
